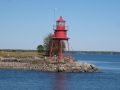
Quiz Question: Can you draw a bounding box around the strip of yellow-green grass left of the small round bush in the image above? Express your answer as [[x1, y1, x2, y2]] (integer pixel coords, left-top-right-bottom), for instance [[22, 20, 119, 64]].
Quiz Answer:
[[0, 52, 44, 58]]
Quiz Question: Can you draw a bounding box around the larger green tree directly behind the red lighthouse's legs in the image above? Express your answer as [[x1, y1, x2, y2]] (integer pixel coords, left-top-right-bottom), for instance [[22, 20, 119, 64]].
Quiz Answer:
[[43, 33, 65, 55]]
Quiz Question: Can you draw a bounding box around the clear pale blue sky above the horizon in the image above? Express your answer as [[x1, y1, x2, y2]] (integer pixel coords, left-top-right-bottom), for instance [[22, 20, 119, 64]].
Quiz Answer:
[[0, 0, 120, 52]]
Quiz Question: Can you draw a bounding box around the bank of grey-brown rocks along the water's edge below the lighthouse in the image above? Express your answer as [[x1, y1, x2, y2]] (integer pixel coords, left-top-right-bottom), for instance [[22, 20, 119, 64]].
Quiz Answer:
[[0, 57, 101, 72]]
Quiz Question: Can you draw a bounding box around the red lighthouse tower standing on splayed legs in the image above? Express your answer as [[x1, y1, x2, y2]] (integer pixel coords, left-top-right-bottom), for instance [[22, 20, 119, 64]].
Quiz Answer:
[[50, 16, 70, 62]]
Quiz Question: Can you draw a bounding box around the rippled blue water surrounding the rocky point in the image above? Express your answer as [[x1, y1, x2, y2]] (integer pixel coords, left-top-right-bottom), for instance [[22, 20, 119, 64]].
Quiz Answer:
[[0, 54, 120, 90]]
